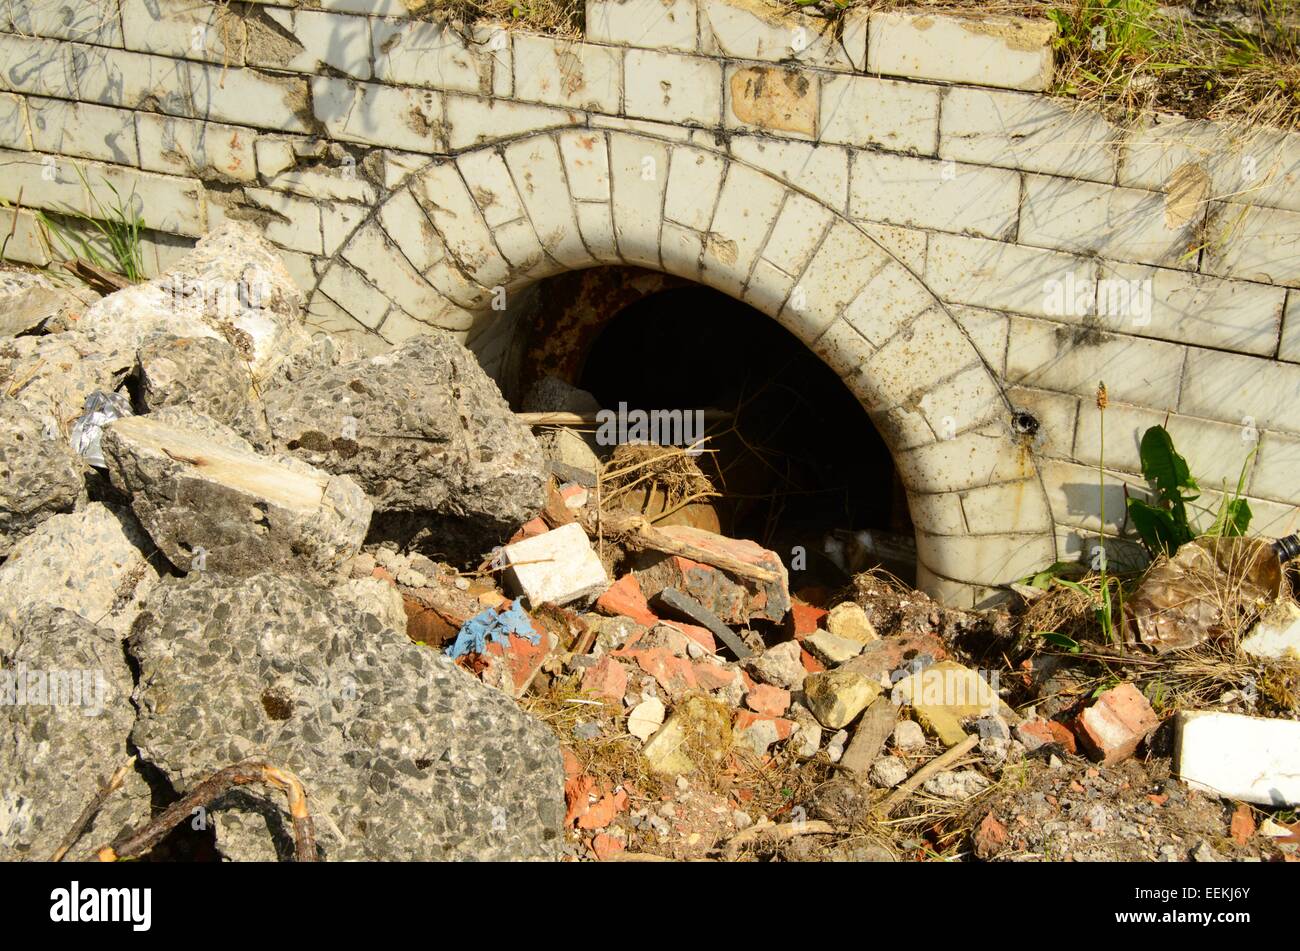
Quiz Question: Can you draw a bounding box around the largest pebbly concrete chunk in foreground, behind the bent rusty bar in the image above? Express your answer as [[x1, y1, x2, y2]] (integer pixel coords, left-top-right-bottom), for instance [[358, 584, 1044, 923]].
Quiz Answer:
[[133, 574, 564, 861]]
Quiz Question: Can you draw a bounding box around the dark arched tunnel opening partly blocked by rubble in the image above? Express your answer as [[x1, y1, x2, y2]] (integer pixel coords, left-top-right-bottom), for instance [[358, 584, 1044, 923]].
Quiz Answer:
[[488, 266, 915, 585]]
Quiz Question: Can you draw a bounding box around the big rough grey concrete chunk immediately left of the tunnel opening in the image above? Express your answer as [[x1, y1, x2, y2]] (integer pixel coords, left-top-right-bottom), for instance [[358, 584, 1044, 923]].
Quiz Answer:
[[265, 331, 546, 551]]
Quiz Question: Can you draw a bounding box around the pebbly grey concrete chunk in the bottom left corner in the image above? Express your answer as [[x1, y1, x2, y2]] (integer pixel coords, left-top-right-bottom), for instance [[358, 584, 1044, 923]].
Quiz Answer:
[[0, 605, 150, 861]]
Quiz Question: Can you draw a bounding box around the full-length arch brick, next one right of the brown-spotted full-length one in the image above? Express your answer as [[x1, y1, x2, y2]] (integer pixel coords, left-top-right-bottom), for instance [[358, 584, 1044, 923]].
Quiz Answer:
[[780, 218, 892, 343]]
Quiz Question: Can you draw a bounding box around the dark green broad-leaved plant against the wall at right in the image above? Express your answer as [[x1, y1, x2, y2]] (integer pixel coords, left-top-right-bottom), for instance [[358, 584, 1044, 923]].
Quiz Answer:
[[1127, 426, 1256, 555]]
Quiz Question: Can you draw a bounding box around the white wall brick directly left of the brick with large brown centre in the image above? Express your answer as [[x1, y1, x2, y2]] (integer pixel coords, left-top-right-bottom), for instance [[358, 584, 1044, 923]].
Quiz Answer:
[[623, 49, 723, 126]]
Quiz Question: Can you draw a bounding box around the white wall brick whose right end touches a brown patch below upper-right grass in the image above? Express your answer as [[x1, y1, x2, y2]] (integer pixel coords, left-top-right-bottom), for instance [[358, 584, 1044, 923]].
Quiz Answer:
[[1019, 175, 1204, 268]]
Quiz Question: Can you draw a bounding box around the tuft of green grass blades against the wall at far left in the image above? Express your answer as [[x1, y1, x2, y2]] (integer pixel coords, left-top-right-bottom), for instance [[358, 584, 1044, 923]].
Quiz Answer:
[[35, 169, 144, 283]]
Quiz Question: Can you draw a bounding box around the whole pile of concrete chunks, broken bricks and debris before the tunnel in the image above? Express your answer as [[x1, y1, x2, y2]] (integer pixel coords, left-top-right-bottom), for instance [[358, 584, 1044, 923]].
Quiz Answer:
[[0, 223, 1300, 860]]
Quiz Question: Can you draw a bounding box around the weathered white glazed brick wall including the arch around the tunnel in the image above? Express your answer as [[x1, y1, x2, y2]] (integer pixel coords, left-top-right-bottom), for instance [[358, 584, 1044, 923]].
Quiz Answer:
[[0, 0, 1300, 603]]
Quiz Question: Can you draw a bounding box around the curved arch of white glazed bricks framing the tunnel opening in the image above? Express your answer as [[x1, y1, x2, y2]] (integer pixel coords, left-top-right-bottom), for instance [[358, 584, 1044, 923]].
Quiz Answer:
[[308, 127, 1056, 605]]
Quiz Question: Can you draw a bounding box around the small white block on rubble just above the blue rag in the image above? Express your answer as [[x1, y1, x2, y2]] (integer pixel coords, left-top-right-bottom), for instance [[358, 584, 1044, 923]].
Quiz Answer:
[[502, 522, 610, 608]]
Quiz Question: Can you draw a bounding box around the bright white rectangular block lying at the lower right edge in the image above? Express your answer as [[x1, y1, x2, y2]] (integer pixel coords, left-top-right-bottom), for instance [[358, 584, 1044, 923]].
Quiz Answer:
[[1174, 711, 1300, 807]]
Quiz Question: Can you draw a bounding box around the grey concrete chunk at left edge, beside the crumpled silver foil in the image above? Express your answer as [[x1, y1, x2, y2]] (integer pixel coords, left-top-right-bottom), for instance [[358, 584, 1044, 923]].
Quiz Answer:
[[0, 398, 83, 557]]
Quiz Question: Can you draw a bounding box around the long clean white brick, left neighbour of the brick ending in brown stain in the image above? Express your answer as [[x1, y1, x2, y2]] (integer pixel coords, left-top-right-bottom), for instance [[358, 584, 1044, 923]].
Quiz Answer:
[[849, 152, 1021, 240]]
